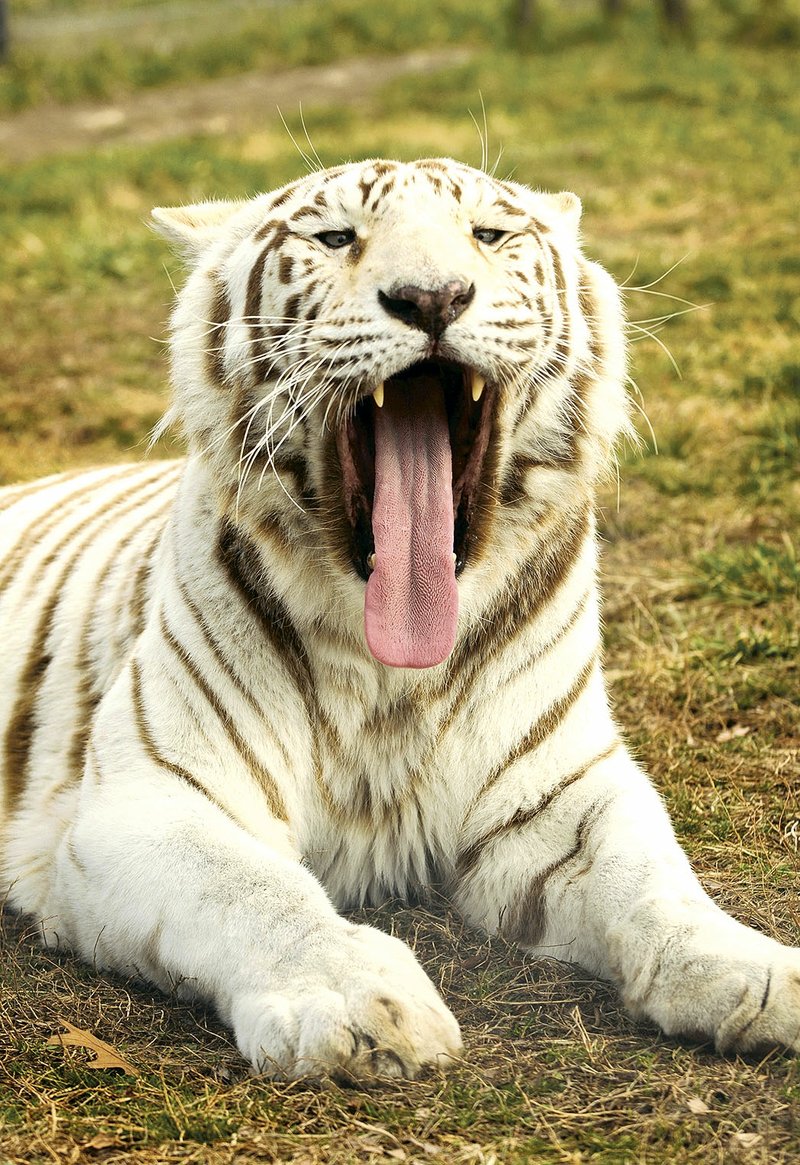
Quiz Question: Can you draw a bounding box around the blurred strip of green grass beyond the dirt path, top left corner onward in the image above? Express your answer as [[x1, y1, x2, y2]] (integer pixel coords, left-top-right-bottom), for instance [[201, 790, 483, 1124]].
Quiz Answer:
[[0, 0, 503, 111]]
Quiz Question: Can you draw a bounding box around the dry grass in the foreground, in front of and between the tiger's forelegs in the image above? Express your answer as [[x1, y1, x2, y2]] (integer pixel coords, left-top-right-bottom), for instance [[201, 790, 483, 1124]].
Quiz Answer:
[[0, 888, 800, 1165]]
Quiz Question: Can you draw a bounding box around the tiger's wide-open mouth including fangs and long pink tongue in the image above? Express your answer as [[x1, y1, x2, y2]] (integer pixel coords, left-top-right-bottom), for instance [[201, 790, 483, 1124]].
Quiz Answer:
[[337, 360, 494, 668]]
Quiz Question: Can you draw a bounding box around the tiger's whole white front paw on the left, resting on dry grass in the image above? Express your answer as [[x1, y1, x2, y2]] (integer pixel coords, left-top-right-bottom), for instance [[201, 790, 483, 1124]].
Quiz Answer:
[[233, 926, 461, 1080]]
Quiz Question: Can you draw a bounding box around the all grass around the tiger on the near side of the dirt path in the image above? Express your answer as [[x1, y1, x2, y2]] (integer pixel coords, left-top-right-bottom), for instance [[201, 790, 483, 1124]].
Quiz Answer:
[[0, 9, 800, 1165]]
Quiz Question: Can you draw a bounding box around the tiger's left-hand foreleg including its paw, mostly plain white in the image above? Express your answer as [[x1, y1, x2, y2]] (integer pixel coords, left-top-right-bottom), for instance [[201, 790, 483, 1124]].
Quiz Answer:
[[37, 678, 461, 1078]]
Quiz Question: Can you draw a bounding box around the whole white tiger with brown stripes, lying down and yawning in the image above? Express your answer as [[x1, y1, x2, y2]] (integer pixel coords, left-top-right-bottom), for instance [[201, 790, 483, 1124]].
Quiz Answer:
[[0, 160, 800, 1079]]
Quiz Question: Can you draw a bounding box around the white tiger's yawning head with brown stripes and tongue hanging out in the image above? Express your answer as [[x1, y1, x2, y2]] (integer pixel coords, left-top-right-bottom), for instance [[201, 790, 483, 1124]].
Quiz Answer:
[[154, 160, 628, 668]]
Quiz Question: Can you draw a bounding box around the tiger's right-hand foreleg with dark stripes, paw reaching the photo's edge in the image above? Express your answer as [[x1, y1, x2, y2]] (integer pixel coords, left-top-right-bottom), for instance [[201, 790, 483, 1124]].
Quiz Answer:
[[458, 746, 800, 1052]]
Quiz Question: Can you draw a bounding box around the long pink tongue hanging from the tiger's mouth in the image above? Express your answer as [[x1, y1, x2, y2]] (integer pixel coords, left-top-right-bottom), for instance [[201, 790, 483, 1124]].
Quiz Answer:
[[364, 380, 459, 668]]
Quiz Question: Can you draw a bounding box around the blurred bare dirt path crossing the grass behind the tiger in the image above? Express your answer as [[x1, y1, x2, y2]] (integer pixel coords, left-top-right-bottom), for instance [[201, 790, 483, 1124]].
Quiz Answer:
[[0, 49, 468, 163]]
